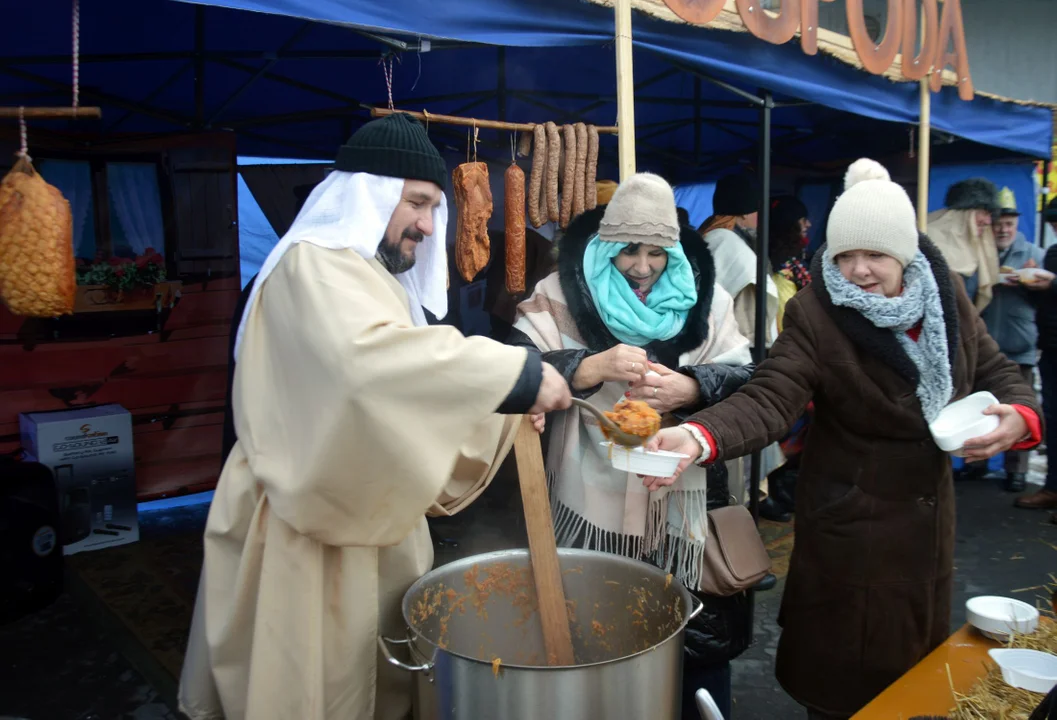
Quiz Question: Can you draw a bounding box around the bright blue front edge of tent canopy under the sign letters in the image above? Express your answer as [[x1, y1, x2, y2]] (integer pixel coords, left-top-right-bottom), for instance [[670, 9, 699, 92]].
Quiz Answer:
[[177, 0, 1053, 158]]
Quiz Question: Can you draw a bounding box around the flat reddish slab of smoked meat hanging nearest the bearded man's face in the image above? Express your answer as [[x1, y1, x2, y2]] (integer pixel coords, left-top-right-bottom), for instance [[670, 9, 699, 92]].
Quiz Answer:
[[451, 163, 492, 282]]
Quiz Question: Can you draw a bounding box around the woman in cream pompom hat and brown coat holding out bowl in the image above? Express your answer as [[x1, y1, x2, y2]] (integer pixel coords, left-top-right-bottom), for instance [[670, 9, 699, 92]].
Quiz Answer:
[[645, 160, 1041, 718]]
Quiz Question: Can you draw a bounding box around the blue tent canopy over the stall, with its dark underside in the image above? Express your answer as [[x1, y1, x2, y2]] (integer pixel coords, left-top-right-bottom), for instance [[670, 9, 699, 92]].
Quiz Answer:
[[0, 0, 1053, 182]]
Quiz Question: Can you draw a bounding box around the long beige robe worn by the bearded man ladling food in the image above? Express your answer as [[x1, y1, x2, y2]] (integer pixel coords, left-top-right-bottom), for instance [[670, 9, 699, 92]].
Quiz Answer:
[[180, 243, 526, 720]]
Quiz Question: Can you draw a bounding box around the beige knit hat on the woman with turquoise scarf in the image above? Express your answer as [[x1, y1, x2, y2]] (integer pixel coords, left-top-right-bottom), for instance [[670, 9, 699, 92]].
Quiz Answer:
[[598, 172, 679, 247]]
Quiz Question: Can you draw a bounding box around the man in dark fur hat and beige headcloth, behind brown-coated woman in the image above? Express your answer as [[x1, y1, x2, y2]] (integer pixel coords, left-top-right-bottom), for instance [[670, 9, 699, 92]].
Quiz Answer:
[[928, 178, 999, 310]]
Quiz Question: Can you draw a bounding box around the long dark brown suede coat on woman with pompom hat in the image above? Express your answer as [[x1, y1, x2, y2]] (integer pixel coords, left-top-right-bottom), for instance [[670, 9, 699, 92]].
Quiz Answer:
[[690, 237, 1042, 715]]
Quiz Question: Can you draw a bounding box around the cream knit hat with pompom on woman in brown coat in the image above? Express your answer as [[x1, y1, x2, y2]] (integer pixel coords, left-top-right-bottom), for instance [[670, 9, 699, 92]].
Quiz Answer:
[[826, 158, 917, 267]]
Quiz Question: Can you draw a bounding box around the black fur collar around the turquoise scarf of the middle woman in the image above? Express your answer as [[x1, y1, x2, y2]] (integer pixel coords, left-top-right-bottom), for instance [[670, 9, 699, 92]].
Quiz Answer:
[[558, 205, 716, 365]]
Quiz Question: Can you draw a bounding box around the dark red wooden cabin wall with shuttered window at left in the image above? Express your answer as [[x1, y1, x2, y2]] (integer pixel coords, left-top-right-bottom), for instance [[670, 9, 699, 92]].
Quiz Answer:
[[0, 132, 240, 500]]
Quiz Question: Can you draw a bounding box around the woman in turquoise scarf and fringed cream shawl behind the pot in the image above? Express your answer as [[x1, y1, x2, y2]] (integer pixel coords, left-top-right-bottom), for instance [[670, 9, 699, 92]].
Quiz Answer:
[[508, 173, 753, 718]]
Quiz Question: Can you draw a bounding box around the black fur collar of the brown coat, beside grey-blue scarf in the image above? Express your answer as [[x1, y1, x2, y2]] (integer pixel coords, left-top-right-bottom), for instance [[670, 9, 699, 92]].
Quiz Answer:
[[811, 235, 959, 387]]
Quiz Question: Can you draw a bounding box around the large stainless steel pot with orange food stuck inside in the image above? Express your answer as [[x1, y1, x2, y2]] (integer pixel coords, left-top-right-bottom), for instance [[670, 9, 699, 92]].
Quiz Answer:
[[378, 549, 702, 720]]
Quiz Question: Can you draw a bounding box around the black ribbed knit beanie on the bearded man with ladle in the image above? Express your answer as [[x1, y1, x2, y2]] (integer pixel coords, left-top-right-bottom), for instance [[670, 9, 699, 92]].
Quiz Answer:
[[334, 113, 448, 190]]
